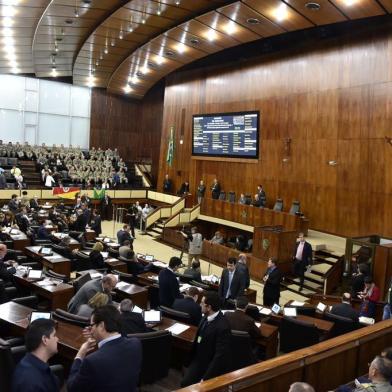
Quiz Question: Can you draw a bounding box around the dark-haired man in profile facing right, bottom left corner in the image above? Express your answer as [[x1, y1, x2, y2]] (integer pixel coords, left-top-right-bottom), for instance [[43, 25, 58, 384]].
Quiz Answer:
[[12, 319, 60, 392]]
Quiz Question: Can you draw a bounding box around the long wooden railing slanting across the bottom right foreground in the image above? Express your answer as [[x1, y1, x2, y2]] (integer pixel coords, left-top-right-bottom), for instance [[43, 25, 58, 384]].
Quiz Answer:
[[178, 320, 392, 392]]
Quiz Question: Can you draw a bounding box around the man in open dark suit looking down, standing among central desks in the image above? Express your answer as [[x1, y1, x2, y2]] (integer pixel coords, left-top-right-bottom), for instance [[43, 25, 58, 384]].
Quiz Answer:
[[218, 257, 245, 301]]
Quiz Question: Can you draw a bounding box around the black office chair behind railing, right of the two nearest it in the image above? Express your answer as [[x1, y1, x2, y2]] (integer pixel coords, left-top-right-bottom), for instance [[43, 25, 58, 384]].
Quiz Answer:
[[279, 316, 319, 353]]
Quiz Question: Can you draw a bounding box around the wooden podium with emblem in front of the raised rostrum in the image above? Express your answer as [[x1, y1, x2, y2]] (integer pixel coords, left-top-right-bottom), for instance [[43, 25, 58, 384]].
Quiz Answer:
[[252, 226, 297, 272]]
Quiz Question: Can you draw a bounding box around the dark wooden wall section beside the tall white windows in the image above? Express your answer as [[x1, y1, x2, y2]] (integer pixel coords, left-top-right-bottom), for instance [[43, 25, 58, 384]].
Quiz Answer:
[[90, 84, 163, 181]]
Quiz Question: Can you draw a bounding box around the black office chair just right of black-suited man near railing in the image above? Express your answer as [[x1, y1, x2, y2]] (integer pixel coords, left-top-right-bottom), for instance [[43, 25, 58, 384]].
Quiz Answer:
[[230, 330, 257, 371]]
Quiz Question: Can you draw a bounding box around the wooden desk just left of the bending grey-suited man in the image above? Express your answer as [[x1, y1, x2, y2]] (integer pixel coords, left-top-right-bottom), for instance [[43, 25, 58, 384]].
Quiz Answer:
[[14, 275, 75, 310]]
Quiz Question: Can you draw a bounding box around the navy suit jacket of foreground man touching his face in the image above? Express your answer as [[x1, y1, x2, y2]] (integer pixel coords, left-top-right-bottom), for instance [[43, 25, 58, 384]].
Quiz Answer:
[[67, 337, 142, 392]]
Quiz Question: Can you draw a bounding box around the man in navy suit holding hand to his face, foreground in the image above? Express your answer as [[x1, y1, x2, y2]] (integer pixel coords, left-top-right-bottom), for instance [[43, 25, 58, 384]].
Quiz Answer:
[[67, 305, 142, 392]]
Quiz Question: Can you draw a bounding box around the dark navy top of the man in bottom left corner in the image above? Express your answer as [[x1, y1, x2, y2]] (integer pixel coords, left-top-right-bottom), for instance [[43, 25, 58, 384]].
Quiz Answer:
[[12, 353, 60, 392]]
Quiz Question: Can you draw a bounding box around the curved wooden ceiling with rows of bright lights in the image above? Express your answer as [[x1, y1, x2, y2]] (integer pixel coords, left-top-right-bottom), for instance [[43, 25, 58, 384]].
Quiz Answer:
[[0, 0, 392, 98]]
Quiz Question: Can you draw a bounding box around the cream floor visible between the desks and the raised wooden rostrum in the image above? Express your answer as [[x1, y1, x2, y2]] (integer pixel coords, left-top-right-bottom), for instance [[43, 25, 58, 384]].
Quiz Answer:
[[102, 221, 346, 305]]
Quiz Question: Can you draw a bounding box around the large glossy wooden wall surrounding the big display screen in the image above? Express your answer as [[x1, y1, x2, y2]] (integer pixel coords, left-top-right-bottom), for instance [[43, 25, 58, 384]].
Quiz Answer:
[[158, 30, 392, 236]]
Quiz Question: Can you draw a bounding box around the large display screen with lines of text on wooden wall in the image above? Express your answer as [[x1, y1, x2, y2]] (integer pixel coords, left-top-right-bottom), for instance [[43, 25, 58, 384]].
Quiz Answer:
[[192, 112, 260, 159]]
